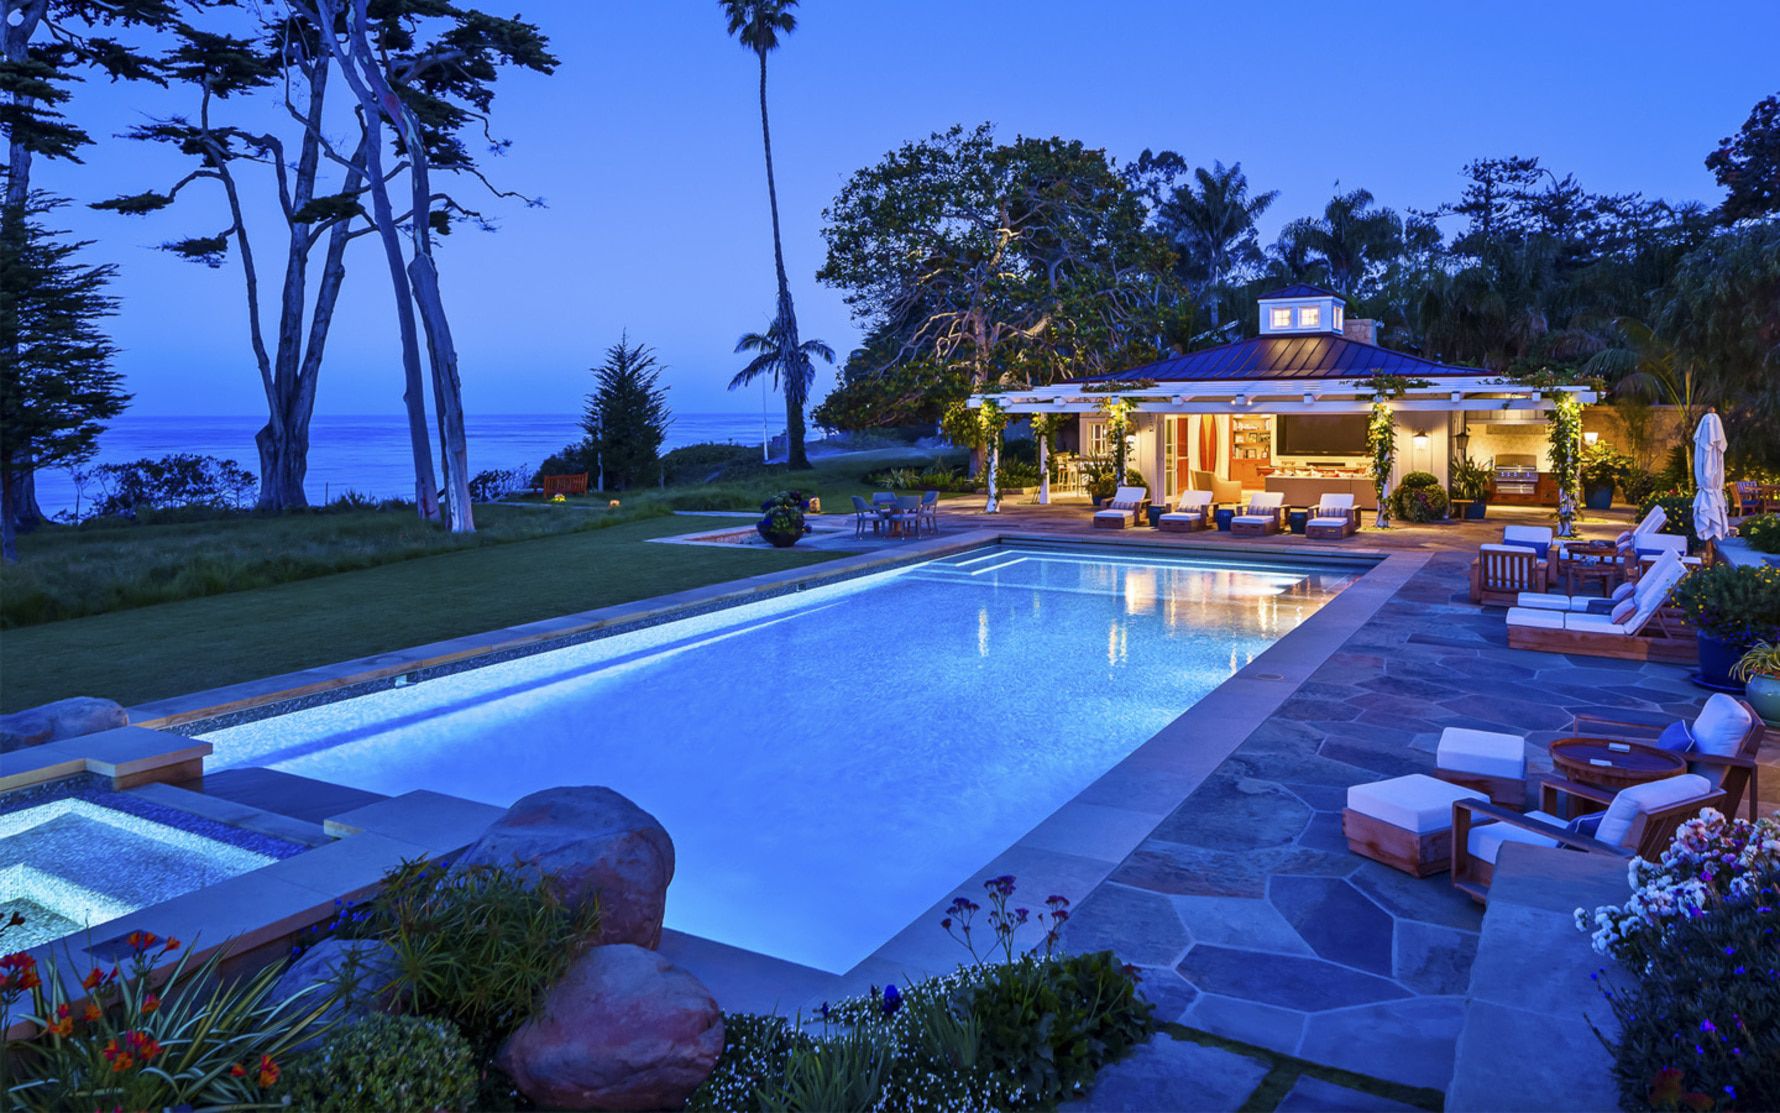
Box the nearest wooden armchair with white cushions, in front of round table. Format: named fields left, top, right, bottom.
left=1452, top=773, right=1725, bottom=903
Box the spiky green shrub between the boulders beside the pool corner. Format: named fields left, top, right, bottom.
left=335, top=860, right=600, bottom=1054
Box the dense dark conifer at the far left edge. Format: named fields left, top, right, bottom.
left=0, top=192, right=130, bottom=561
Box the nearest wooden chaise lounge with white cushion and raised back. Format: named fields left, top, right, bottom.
left=1508, top=552, right=1700, bottom=664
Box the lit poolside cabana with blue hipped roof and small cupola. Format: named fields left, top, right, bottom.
left=970, top=285, right=1595, bottom=509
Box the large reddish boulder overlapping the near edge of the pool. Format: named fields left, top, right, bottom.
left=454, top=785, right=673, bottom=947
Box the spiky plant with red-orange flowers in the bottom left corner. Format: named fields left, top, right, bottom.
left=0, top=931, right=329, bottom=1111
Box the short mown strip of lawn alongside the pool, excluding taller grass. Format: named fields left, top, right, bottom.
left=0, top=509, right=837, bottom=711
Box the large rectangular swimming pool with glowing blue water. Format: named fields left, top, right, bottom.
left=201, top=545, right=1358, bottom=972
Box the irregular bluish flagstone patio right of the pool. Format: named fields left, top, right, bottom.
left=1066, top=552, right=1737, bottom=1108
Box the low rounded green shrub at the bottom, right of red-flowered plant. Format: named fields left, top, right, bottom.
left=290, top=1015, right=477, bottom=1113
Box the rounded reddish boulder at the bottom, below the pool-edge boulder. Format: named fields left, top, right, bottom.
left=497, top=944, right=723, bottom=1109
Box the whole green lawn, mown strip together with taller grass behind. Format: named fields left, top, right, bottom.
left=0, top=451, right=961, bottom=711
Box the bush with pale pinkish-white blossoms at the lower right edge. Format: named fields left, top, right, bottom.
left=1577, top=808, right=1780, bottom=1109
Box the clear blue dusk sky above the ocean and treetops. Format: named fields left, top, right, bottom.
left=37, top=0, right=1780, bottom=415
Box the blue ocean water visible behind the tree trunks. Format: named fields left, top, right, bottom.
left=37, top=413, right=785, bottom=515
